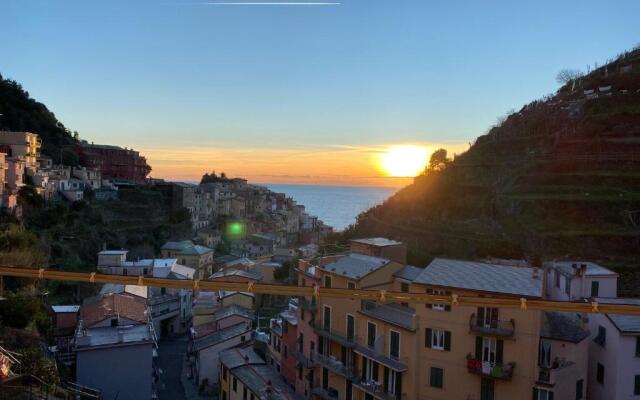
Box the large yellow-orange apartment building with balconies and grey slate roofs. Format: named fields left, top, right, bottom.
left=302, top=254, right=587, bottom=400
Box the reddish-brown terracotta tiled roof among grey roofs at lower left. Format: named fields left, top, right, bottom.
left=80, top=293, right=148, bottom=328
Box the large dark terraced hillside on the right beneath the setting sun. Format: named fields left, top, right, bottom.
left=345, top=49, right=640, bottom=296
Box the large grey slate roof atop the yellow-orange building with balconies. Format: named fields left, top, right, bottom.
left=414, top=258, right=542, bottom=297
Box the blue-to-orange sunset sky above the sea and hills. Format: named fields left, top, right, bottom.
left=5, top=0, right=640, bottom=186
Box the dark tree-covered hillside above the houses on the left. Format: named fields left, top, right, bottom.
left=0, top=75, right=78, bottom=165
